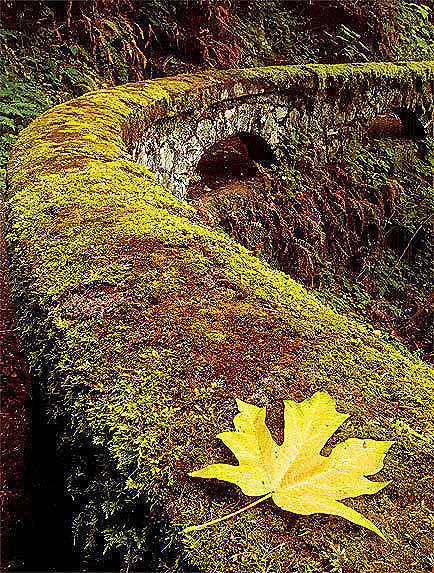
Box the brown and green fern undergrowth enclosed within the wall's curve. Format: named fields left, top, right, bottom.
left=193, top=134, right=433, bottom=360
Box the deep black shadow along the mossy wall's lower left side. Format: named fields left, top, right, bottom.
left=8, top=366, right=199, bottom=573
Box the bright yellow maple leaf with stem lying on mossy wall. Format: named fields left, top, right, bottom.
left=184, top=392, right=394, bottom=539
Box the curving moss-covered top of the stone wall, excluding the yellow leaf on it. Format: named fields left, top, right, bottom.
left=7, top=62, right=434, bottom=573
